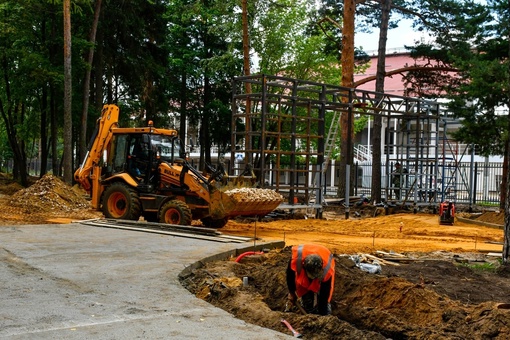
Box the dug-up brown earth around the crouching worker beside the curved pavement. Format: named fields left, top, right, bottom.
left=182, top=247, right=510, bottom=339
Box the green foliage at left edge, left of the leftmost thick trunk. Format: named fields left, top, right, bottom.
left=0, top=0, right=63, bottom=182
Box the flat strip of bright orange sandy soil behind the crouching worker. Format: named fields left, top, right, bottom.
left=221, top=212, right=503, bottom=254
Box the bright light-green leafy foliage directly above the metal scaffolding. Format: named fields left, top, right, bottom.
left=251, top=0, right=348, bottom=84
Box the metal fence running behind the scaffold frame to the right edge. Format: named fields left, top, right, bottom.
left=256, top=162, right=503, bottom=206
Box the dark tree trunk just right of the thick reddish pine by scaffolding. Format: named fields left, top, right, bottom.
left=371, top=0, right=391, bottom=202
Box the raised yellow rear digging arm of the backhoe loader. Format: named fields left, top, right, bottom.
left=74, top=105, right=119, bottom=193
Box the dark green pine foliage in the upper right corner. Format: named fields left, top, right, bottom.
left=407, top=0, right=510, bottom=156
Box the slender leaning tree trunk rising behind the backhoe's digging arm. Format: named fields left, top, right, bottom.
left=78, top=0, right=102, bottom=161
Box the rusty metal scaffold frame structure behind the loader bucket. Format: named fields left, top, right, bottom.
left=229, top=75, right=446, bottom=209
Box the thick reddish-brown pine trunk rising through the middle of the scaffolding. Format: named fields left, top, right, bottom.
left=338, top=0, right=356, bottom=202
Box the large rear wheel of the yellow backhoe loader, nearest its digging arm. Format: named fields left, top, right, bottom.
left=103, top=183, right=141, bottom=221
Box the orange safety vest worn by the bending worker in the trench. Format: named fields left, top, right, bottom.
left=290, top=244, right=335, bottom=302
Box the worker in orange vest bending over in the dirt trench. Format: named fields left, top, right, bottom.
left=287, top=244, right=335, bottom=315
